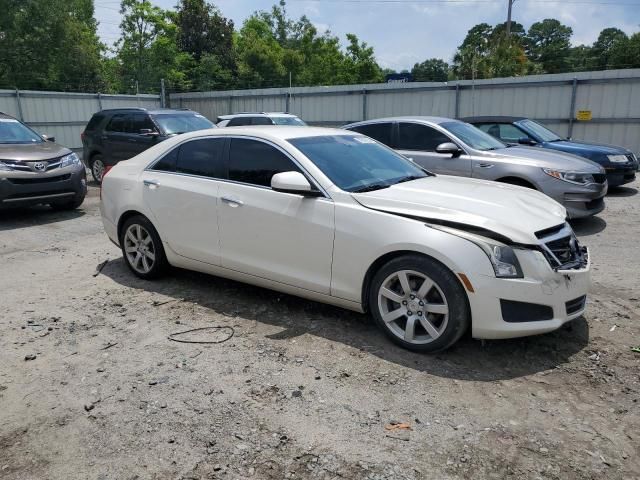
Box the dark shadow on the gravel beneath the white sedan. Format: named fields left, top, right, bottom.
left=102, top=258, right=589, bottom=382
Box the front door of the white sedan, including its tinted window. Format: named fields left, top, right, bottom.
left=218, top=138, right=334, bottom=294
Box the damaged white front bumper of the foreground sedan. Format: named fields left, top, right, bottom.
left=469, top=251, right=591, bottom=339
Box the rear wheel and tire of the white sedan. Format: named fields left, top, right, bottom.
left=120, top=215, right=168, bottom=280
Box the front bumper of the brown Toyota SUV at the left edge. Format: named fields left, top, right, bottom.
left=0, top=166, right=87, bottom=209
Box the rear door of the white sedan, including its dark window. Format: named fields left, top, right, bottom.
left=142, top=137, right=226, bottom=265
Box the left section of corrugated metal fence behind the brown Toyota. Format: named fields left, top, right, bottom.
left=0, top=90, right=160, bottom=150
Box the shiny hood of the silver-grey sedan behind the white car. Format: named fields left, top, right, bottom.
left=483, top=146, right=604, bottom=173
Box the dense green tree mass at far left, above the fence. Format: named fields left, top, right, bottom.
left=0, top=0, right=104, bottom=91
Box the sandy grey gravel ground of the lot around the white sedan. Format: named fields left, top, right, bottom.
left=0, top=182, right=640, bottom=480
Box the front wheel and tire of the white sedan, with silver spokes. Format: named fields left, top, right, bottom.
left=369, top=255, right=471, bottom=353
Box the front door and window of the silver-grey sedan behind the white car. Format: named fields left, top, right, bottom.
left=396, top=122, right=471, bottom=177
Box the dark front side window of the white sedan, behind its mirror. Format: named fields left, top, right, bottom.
left=229, top=138, right=300, bottom=187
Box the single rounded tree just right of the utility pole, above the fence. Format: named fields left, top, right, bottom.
left=526, top=18, right=573, bottom=73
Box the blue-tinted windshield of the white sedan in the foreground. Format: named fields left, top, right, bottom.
left=288, top=135, right=430, bottom=192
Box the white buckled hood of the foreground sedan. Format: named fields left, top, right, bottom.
left=352, top=175, right=567, bottom=244
